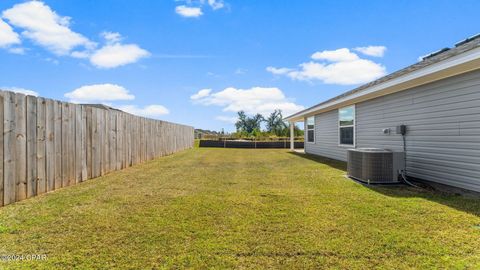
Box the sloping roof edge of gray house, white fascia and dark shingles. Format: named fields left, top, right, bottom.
left=285, top=34, right=480, bottom=122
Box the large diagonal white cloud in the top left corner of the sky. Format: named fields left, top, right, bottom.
left=2, top=1, right=95, bottom=55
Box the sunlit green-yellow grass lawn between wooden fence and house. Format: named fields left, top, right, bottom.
left=0, top=148, right=480, bottom=269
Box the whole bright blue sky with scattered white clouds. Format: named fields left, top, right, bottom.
left=0, top=0, right=480, bottom=131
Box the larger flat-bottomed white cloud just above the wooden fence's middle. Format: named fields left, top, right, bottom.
left=65, top=83, right=135, bottom=103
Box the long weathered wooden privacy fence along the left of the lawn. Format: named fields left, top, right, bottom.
left=0, top=91, right=194, bottom=206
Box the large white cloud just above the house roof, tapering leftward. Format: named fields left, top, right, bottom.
left=267, top=48, right=386, bottom=85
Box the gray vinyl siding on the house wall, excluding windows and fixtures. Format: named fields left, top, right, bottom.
left=305, top=71, right=480, bottom=191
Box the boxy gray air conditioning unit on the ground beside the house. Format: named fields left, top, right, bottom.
left=347, top=148, right=405, bottom=184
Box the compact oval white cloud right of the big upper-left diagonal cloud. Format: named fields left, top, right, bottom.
left=90, top=43, right=150, bottom=68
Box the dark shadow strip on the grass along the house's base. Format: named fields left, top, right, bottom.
left=290, top=152, right=480, bottom=217
